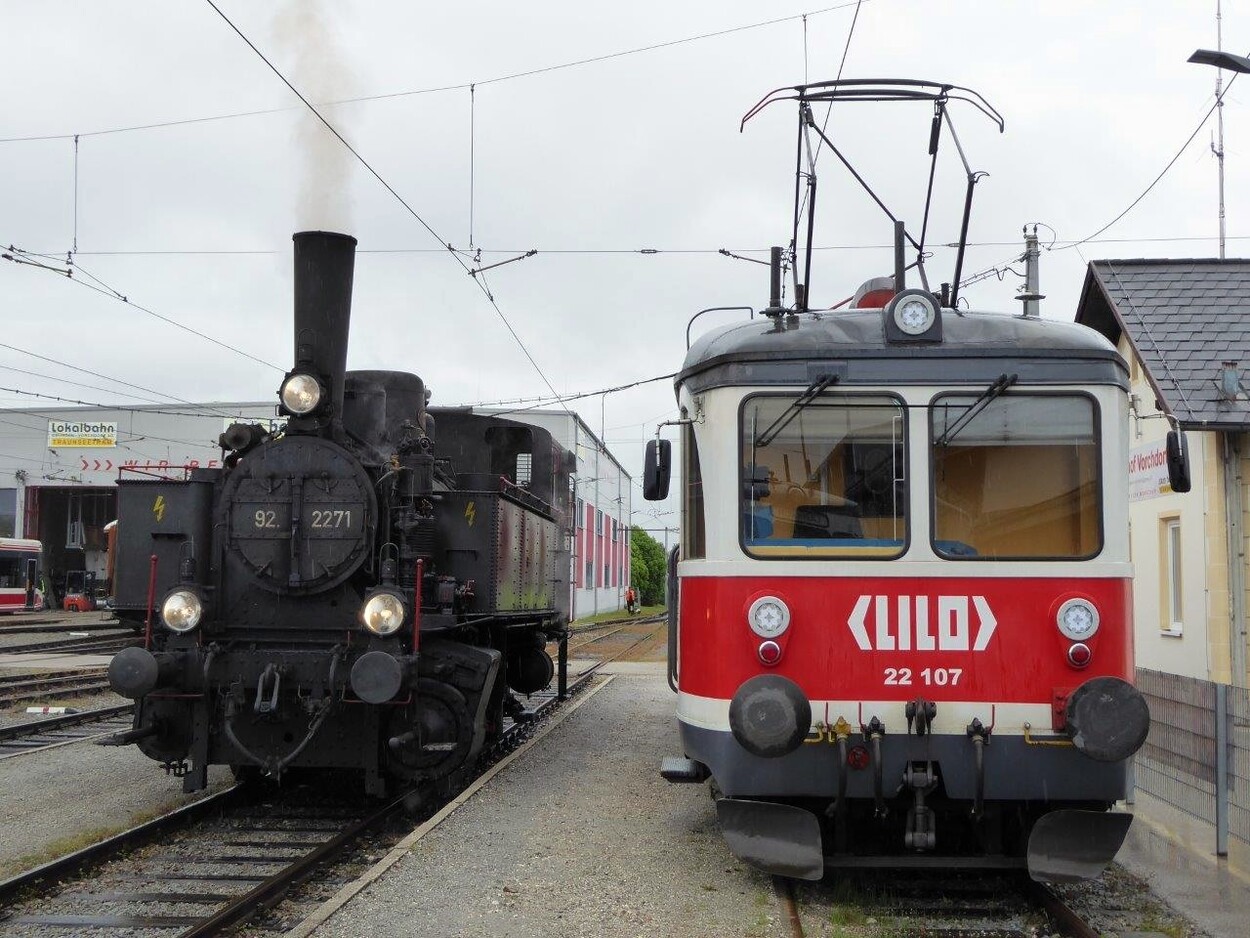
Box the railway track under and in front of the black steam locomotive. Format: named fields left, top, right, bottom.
left=0, top=655, right=630, bottom=938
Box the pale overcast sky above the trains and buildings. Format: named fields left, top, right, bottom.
left=0, top=0, right=1250, bottom=535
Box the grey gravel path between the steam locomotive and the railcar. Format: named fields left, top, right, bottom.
left=314, top=664, right=789, bottom=938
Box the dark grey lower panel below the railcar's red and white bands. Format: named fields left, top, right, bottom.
left=680, top=723, right=1126, bottom=802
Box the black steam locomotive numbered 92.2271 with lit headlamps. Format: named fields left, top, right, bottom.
left=109, top=231, right=575, bottom=794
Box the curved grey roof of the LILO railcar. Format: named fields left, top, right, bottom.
left=675, top=309, right=1128, bottom=391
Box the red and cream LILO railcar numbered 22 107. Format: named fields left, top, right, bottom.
left=666, top=297, right=1149, bottom=879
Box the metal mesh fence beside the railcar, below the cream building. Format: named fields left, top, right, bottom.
left=1134, top=668, right=1250, bottom=857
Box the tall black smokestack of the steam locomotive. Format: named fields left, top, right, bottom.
left=291, top=231, right=356, bottom=421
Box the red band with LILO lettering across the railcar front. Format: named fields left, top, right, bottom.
left=680, top=577, right=1133, bottom=703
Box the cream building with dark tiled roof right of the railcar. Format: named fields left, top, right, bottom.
left=1076, top=258, right=1250, bottom=687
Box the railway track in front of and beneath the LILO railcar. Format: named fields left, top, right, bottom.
left=774, top=870, right=1099, bottom=938
